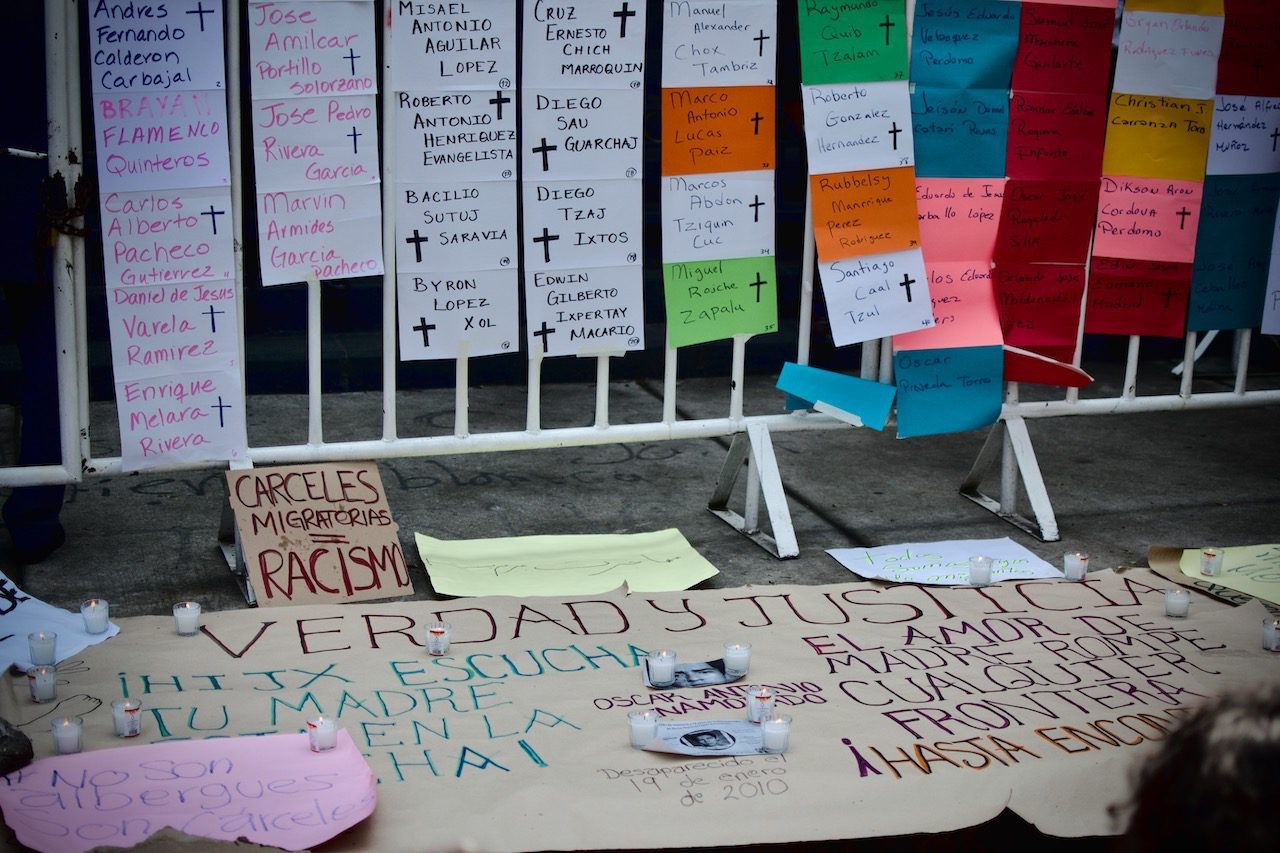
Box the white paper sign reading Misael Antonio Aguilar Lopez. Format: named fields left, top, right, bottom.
left=392, top=0, right=514, bottom=92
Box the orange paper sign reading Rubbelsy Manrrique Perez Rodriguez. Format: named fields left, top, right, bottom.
left=809, top=167, right=920, bottom=261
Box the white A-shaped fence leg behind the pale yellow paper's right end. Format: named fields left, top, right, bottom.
left=707, top=424, right=800, bottom=560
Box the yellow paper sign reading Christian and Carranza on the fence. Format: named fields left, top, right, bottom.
left=1102, top=92, right=1213, bottom=181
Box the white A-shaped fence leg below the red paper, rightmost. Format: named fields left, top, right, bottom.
left=960, top=418, right=1062, bottom=542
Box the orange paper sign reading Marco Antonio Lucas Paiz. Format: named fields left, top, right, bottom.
left=662, top=86, right=776, bottom=175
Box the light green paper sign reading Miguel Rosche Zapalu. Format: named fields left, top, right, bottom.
left=662, top=256, right=778, bottom=347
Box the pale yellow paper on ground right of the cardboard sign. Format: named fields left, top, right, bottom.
left=413, top=528, right=719, bottom=596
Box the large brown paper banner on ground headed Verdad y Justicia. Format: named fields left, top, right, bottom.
left=0, top=569, right=1280, bottom=852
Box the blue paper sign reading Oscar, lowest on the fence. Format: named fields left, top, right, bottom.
left=893, top=347, right=1005, bottom=438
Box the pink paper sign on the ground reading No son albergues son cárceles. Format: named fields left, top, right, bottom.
left=0, top=730, right=378, bottom=853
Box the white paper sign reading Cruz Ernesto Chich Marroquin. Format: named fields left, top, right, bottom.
left=524, top=0, right=645, bottom=90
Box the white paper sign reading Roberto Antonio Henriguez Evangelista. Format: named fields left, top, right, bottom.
left=396, top=90, right=516, bottom=182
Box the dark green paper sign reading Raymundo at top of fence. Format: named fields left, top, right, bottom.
left=799, top=0, right=908, bottom=86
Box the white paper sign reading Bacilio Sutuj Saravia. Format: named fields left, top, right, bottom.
left=396, top=181, right=517, bottom=273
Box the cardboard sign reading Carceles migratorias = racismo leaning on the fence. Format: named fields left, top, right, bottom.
left=227, top=462, right=413, bottom=607
